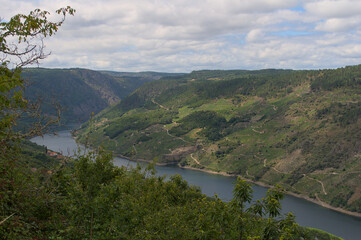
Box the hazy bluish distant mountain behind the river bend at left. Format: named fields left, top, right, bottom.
left=23, top=68, right=181, bottom=124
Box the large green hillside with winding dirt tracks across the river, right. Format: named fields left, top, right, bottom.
left=78, top=65, right=361, bottom=212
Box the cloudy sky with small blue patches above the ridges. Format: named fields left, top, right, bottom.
left=0, top=0, right=361, bottom=72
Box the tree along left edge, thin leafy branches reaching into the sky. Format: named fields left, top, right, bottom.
left=0, top=7, right=75, bottom=239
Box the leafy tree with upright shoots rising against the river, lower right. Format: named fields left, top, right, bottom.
left=232, top=178, right=299, bottom=240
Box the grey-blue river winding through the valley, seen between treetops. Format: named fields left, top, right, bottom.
left=31, top=131, right=361, bottom=240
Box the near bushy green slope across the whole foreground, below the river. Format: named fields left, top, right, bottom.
left=0, top=66, right=340, bottom=240
